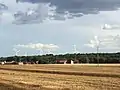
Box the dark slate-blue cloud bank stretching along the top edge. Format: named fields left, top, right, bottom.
left=16, top=0, right=120, bottom=14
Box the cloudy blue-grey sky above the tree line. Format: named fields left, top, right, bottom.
left=0, top=0, right=120, bottom=56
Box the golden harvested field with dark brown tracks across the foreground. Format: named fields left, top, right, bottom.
left=0, top=64, right=120, bottom=90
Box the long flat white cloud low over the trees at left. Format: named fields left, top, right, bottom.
left=15, top=43, right=59, bottom=51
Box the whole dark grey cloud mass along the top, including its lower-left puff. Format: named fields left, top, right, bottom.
left=13, top=0, right=120, bottom=24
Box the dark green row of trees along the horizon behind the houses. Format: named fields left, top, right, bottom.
left=0, top=53, right=120, bottom=64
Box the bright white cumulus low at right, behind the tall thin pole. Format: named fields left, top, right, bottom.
left=85, top=35, right=120, bottom=49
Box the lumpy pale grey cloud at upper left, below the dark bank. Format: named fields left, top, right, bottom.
left=13, top=3, right=75, bottom=24
